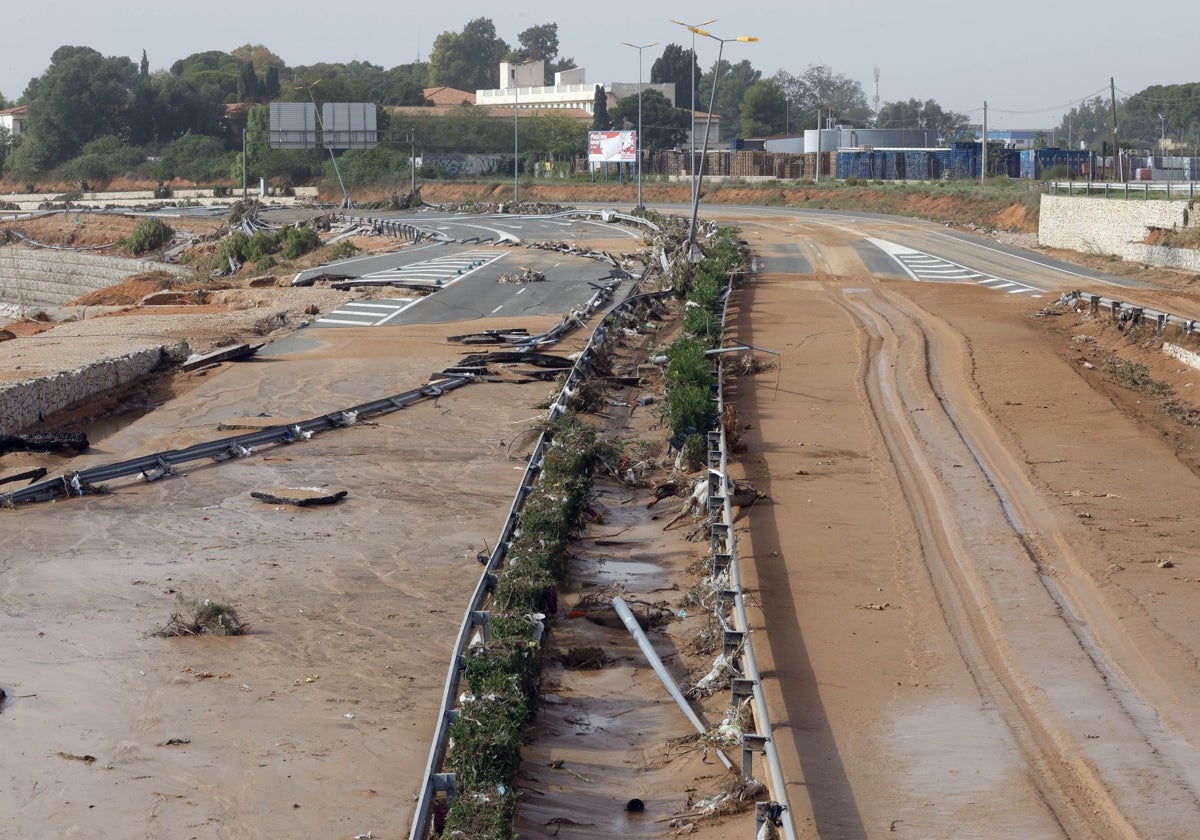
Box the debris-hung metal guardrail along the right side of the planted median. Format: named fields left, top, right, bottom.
left=708, top=283, right=797, bottom=840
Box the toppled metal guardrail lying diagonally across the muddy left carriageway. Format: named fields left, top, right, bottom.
left=0, top=376, right=474, bottom=505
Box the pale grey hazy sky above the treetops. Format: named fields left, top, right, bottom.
left=0, top=0, right=1200, bottom=128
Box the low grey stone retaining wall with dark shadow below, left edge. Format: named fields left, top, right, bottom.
left=0, top=346, right=164, bottom=436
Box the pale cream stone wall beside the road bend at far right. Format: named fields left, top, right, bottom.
left=1038, top=196, right=1192, bottom=259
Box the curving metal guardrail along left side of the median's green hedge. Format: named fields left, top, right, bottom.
left=408, top=281, right=672, bottom=840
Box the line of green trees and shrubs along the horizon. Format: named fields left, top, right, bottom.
left=0, top=18, right=1200, bottom=190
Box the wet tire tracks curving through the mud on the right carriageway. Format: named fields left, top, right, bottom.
left=840, top=287, right=1200, bottom=838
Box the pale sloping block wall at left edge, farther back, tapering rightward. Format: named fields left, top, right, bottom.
left=0, top=245, right=184, bottom=308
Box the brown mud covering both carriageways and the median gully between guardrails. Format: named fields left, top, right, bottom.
left=0, top=198, right=1200, bottom=838
